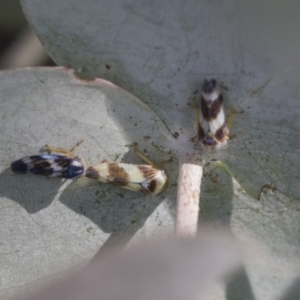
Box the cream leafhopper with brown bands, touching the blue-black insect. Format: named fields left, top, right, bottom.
left=85, top=145, right=168, bottom=195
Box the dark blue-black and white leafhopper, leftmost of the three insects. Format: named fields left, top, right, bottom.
left=10, top=141, right=86, bottom=179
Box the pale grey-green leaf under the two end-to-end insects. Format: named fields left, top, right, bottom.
left=0, top=68, right=177, bottom=299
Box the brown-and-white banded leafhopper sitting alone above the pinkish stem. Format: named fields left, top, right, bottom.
left=196, top=79, right=229, bottom=152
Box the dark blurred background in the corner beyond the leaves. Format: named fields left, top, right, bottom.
left=0, top=0, right=55, bottom=70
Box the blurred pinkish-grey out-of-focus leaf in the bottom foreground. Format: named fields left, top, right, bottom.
left=22, top=231, right=242, bottom=300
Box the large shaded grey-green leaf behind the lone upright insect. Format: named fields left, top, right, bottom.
left=22, top=0, right=300, bottom=200
